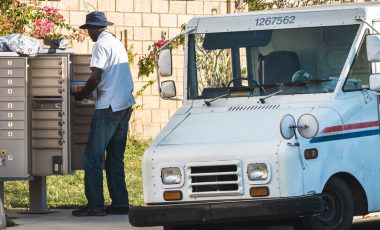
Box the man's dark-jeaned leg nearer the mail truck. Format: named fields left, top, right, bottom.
left=106, top=108, right=132, bottom=208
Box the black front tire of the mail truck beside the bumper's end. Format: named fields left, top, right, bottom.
left=295, top=177, right=354, bottom=230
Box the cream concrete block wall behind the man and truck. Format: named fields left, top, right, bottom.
left=42, top=0, right=230, bottom=138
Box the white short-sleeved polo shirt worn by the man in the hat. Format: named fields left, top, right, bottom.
left=90, top=31, right=135, bottom=112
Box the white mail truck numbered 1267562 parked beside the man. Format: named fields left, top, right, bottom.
left=129, top=3, right=380, bottom=230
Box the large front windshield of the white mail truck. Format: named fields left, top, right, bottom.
left=188, top=24, right=359, bottom=99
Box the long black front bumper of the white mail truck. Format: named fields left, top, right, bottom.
left=129, top=195, right=323, bottom=227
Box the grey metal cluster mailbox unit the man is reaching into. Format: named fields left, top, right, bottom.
left=0, top=52, right=94, bottom=203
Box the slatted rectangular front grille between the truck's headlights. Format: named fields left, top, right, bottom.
left=189, top=162, right=242, bottom=197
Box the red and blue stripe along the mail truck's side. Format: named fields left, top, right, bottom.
left=310, top=121, right=380, bottom=143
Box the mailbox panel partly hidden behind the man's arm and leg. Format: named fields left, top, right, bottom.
left=71, top=55, right=95, bottom=170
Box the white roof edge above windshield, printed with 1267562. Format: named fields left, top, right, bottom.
left=187, top=2, right=380, bottom=33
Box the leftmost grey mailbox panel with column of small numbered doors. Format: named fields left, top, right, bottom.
left=0, top=57, right=30, bottom=179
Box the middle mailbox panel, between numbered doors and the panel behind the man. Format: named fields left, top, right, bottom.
left=30, top=55, right=71, bottom=176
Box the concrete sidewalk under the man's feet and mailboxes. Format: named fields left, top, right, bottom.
left=5, top=209, right=162, bottom=230
